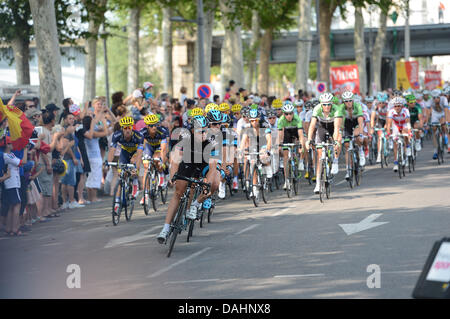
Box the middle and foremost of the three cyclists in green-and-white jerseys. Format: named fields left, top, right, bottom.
left=306, top=93, right=343, bottom=194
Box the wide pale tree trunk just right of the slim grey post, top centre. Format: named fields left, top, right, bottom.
left=220, top=0, right=244, bottom=96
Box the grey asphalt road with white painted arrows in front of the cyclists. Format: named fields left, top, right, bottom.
left=0, top=142, right=450, bottom=299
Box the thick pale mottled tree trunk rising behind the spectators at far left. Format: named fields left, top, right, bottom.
left=30, top=0, right=64, bottom=107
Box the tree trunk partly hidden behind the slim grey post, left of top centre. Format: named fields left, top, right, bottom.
left=194, top=2, right=217, bottom=82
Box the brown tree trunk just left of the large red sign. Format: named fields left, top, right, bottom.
left=317, top=0, right=337, bottom=84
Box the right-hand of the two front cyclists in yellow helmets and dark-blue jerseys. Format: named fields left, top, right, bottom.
left=139, top=114, right=170, bottom=205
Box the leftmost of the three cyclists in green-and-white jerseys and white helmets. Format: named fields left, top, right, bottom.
left=278, top=103, right=305, bottom=189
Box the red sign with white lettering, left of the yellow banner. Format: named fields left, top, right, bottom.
left=330, top=64, right=359, bottom=94
